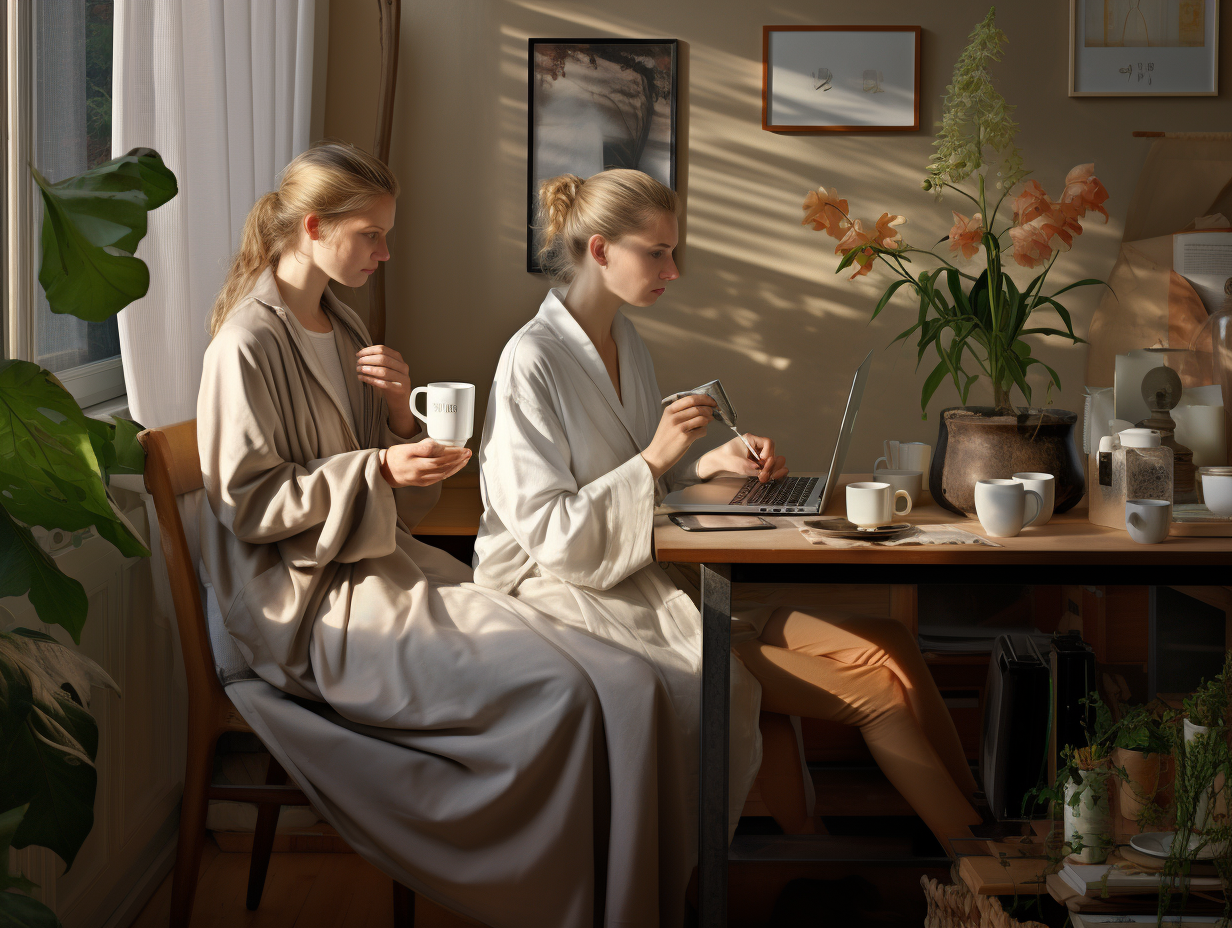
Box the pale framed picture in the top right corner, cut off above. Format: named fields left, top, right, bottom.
left=1069, top=0, right=1220, bottom=96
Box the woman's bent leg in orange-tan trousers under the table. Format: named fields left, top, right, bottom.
left=737, top=616, right=981, bottom=850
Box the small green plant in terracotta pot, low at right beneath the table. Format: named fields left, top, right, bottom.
left=1111, top=702, right=1172, bottom=831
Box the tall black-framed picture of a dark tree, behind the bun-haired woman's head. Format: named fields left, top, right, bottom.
left=526, top=38, right=676, bottom=272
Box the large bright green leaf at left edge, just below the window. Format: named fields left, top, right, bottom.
left=0, top=361, right=149, bottom=557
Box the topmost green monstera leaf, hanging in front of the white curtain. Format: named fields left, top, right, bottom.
left=31, top=148, right=177, bottom=322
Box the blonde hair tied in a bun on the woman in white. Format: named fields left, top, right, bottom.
left=535, top=168, right=679, bottom=283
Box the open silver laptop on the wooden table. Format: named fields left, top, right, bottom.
left=663, top=351, right=872, bottom=515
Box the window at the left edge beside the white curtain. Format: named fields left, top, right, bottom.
left=6, top=0, right=124, bottom=405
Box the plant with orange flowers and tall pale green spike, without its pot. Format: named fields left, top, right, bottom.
left=803, top=7, right=1108, bottom=418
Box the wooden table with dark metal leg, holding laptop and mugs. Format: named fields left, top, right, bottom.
left=654, top=474, right=1232, bottom=928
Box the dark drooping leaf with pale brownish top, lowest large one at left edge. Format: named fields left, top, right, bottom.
left=0, top=629, right=118, bottom=866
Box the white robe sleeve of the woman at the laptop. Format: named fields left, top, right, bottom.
left=483, top=357, right=654, bottom=590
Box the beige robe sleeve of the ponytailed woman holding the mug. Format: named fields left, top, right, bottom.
left=197, top=327, right=397, bottom=567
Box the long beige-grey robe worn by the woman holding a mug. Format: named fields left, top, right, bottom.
left=197, top=270, right=691, bottom=928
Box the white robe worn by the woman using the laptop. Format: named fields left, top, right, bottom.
left=474, top=290, right=761, bottom=828
